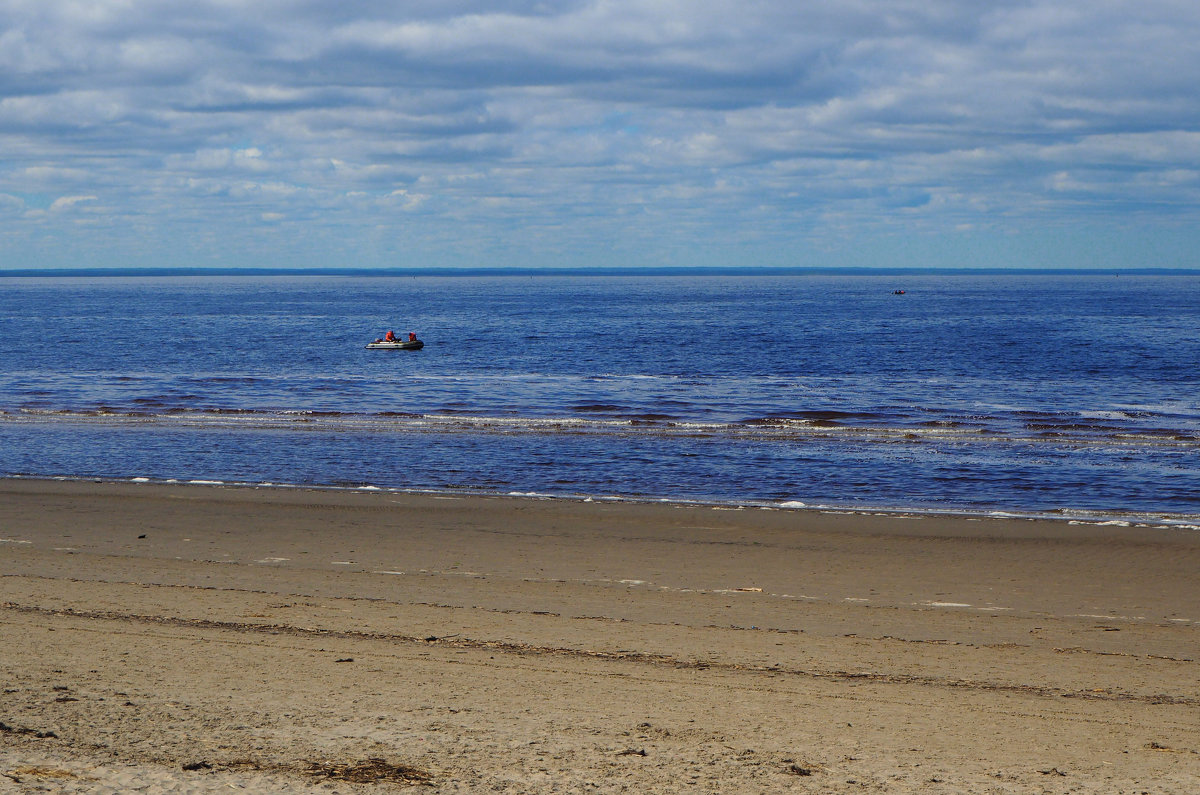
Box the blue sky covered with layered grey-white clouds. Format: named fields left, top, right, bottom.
left=0, top=0, right=1200, bottom=269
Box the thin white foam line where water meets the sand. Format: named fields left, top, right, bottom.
left=9, top=474, right=1200, bottom=531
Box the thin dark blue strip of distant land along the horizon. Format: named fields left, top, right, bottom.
left=0, top=265, right=1200, bottom=279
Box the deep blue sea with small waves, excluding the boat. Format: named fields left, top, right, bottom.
left=0, top=273, right=1200, bottom=525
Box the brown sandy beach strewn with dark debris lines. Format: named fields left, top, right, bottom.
left=0, top=479, right=1200, bottom=793
